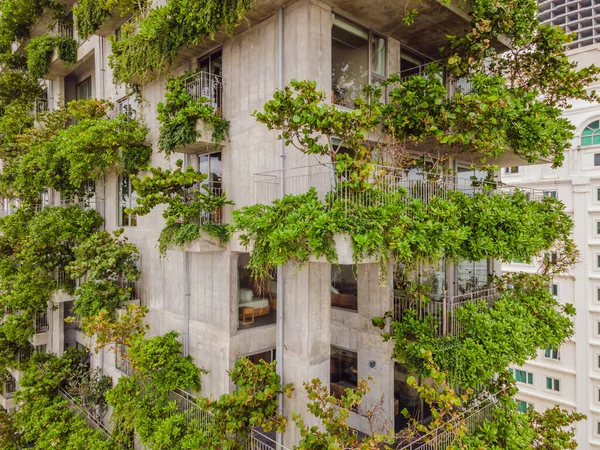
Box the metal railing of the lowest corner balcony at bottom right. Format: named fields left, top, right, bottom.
left=397, top=392, right=504, bottom=450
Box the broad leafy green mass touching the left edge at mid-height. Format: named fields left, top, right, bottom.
left=0, top=206, right=102, bottom=346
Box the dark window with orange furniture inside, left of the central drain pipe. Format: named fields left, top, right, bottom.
left=237, top=253, right=277, bottom=329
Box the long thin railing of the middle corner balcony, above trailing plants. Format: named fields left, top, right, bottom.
left=254, top=163, right=544, bottom=206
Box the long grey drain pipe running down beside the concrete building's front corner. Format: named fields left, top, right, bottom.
left=277, top=8, right=285, bottom=450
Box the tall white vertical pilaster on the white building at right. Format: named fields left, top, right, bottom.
left=572, top=177, right=595, bottom=443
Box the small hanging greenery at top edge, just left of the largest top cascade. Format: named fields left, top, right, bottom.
left=73, top=0, right=146, bottom=39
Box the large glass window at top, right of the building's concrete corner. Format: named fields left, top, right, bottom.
left=331, top=14, right=387, bottom=108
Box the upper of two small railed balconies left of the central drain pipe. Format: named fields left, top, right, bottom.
left=178, top=72, right=223, bottom=153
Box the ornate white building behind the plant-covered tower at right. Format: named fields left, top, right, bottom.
left=502, top=0, right=600, bottom=450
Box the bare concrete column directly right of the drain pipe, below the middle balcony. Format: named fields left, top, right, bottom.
left=277, top=263, right=331, bottom=448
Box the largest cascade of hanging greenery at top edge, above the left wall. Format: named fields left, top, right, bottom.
left=109, top=0, right=252, bottom=83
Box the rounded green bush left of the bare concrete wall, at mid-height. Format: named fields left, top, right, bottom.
left=67, top=228, right=140, bottom=318
